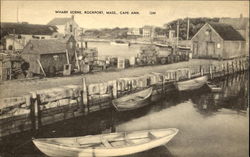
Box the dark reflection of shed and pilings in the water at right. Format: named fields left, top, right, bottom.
left=191, top=72, right=249, bottom=114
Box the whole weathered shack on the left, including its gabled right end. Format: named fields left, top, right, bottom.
left=21, top=37, right=76, bottom=76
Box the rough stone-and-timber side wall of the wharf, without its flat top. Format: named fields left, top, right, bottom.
left=0, top=58, right=249, bottom=140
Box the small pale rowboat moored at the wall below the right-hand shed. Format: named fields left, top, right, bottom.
left=175, top=76, right=208, bottom=91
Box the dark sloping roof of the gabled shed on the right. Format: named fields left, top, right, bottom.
left=208, top=22, right=245, bottom=41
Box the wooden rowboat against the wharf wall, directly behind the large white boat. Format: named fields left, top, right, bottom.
left=112, top=87, right=153, bottom=111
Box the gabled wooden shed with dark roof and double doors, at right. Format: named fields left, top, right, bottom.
left=191, top=23, right=246, bottom=59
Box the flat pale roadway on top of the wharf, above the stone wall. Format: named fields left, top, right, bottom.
left=0, top=59, right=226, bottom=99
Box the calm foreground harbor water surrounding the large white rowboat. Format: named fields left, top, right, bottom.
left=0, top=73, right=249, bottom=157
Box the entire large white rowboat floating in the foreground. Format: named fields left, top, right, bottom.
left=33, top=128, right=178, bottom=157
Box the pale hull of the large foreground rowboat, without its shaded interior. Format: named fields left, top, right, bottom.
left=33, top=128, right=178, bottom=157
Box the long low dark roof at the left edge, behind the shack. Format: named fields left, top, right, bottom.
left=1, top=22, right=57, bottom=38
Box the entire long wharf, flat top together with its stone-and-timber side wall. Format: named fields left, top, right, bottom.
left=0, top=58, right=249, bottom=140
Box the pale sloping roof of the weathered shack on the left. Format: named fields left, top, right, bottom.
left=22, top=39, right=66, bottom=54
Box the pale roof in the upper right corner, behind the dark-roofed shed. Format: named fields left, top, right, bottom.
left=219, top=17, right=249, bottom=30
